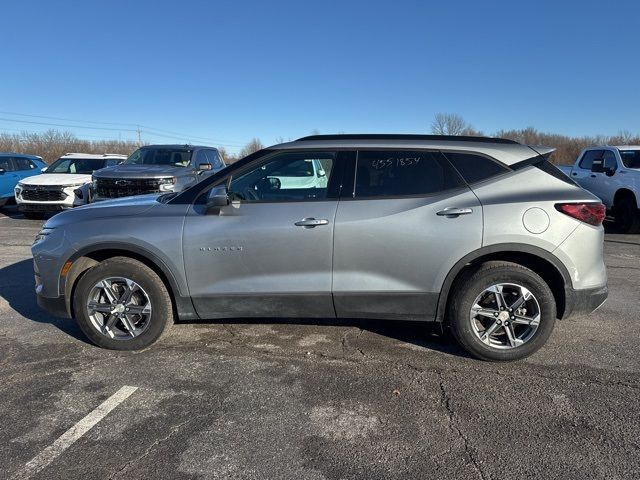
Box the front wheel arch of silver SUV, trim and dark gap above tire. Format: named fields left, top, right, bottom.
left=61, top=242, right=198, bottom=320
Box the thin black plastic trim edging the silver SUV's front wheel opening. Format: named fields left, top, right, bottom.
left=65, top=241, right=200, bottom=320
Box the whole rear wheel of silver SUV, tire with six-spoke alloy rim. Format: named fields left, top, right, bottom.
left=448, top=262, right=557, bottom=361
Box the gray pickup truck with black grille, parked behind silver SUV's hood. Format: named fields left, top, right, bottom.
left=92, top=145, right=225, bottom=201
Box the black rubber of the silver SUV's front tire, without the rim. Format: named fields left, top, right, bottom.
left=73, top=257, right=174, bottom=350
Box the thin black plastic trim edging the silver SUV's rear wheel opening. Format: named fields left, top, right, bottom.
left=435, top=243, right=573, bottom=322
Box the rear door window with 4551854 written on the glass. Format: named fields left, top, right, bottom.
left=354, top=150, right=462, bottom=198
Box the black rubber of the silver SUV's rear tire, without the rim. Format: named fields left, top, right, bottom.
left=448, top=262, right=557, bottom=361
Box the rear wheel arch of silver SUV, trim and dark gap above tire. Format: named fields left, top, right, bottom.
left=435, top=243, right=573, bottom=322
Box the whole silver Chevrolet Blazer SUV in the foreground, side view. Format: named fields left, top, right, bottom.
left=32, top=135, right=607, bottom=360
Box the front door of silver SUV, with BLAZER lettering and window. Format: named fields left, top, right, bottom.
left=183, top=151, right=341, bottom=318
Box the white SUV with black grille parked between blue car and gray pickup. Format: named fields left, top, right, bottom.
left=15, top=153, right=127, bottom=218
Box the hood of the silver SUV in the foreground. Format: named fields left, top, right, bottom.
left=44, top=194, right=163, bottom=228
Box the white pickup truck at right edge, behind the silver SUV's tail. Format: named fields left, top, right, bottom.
left=560, top=146, right=640, bottom=233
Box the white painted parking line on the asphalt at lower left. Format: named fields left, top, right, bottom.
left=13, top=386, right=138, bottom=480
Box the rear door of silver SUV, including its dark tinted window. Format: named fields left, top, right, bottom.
left=333, top=150, right=482, bottom=320
